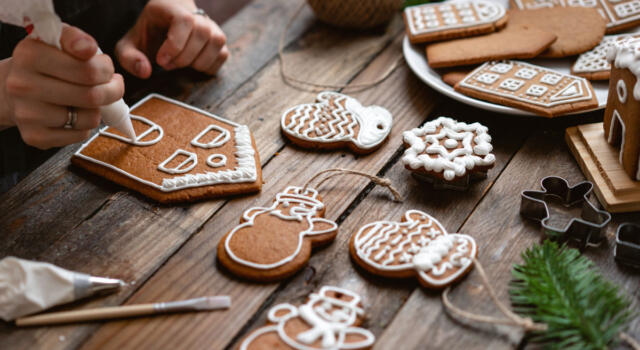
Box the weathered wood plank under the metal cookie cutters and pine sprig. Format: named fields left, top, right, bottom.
left=376, top=132, right=640, bottom=349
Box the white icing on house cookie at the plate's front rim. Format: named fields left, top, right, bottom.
left=459, top=61, right=593, bottom=107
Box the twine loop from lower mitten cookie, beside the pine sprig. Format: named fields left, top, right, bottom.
left=442, top=258, right=547, bottom=331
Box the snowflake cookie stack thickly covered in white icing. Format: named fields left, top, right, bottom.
left=402, top=117, right=496, bottom=187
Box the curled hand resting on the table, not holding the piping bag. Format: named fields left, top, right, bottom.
left=116, top=0, right=229, bottom=78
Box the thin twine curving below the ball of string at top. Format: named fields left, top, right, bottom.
left=278, top=1, right=403, bottom=92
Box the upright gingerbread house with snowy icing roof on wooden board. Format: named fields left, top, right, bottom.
left=604, top=39, right=640, bottom=181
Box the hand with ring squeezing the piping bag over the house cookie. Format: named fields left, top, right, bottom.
left=0, top=26, right=124, bottom=149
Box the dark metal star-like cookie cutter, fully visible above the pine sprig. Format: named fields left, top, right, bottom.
left=520, top=176, right=611, bottom=250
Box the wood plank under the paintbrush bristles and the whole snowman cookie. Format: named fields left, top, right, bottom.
left=76, top=40, right=440, bottom=349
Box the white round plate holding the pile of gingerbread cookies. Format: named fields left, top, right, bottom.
left=402, top=35, right=609, bottom=115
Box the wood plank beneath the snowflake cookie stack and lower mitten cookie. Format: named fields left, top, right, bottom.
left=222, top=98, right=527, bottom=349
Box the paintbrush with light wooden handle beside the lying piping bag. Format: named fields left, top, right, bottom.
left=16, top=296, right=231, bottom=326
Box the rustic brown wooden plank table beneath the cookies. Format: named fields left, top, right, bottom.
left=0, top=0, right=640, bottom=349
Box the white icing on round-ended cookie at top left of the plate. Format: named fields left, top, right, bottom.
left=404, top=0, right=507, bottom=35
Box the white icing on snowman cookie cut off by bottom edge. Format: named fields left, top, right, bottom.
left=240, top=286, right=375, bottom=350
